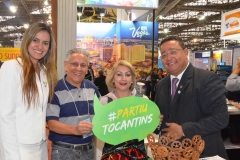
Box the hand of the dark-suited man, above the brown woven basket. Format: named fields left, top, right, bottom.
left=162, top=123, right=183, bottom=139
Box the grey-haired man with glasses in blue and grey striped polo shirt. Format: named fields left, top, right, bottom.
left=47, top=48, right=100, bottom=160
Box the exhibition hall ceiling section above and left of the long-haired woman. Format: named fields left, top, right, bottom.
left=0, top=0, right=51, bottom=47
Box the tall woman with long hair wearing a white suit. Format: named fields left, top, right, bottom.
left=0, top=23, right=57, bottom=160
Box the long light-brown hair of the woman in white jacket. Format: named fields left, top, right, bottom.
left=20, top=22, right=58, bottom=108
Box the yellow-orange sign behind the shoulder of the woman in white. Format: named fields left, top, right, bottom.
left=0, top=48, right=20, bottom=62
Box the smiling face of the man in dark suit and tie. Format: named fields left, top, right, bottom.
left=160, top=40, right=188, bottom=76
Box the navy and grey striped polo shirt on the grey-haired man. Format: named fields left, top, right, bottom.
left=46, top=75, right=100, bottom=144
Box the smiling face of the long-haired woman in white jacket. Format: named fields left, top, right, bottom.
left=28, top=31, right=50, bottom=65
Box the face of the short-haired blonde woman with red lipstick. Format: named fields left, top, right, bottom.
left=113, top=65, right=133, bottom=92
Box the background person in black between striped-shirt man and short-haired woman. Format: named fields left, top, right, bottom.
left=94, top=70, right=109, bottom=96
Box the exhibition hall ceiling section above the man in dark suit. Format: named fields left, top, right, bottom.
left=155, top=0, right=240, bottom=50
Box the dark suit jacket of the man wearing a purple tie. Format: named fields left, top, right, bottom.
left=155, top=64, right=228, bottom=158
